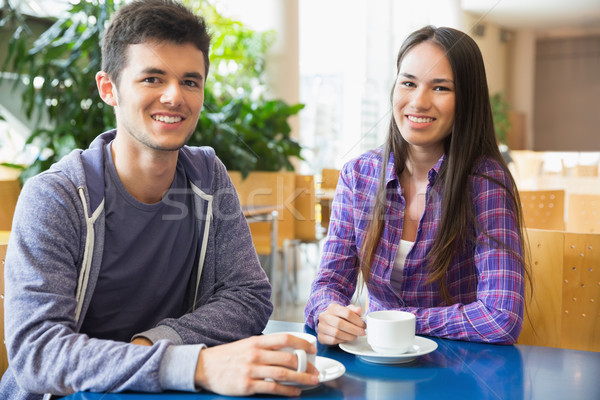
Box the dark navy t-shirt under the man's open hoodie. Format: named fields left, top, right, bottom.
left=81, top=144, right=198, bottom=342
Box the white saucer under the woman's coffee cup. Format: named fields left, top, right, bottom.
left=340, top=336, right=437, bottom=364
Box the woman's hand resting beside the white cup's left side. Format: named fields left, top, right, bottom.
left=317, top=303, right=367, bottom=345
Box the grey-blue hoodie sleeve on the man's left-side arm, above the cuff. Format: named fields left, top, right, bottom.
left=5, top=172, right=190, bottom=395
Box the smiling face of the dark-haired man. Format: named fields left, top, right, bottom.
left=105, top=42, right=206, bottom=151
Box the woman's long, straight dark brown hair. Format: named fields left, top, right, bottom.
left=360, top=26, right=527, bottom=305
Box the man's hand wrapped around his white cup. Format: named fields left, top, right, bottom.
left=195, top=333, right=319, bottom=396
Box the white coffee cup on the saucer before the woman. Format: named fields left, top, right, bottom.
left=367, top=310, right=416, bottom=355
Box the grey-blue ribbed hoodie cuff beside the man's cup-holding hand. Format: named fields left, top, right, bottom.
left=158, top=344, right=206, bottom=392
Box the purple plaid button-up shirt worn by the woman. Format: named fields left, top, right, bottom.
left=305, top=150, right=524, bottom=344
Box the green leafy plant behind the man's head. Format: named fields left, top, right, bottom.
left=0, top=0, right=303, bottom=179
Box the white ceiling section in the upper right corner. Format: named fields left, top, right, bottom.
left=461, top=0, right=600, bottom=30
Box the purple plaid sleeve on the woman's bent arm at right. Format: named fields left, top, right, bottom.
left=405, top=162, right=524, bottom=344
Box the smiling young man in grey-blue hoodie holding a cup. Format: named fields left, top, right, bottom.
left=0, top=0, right=318, bottom=399
